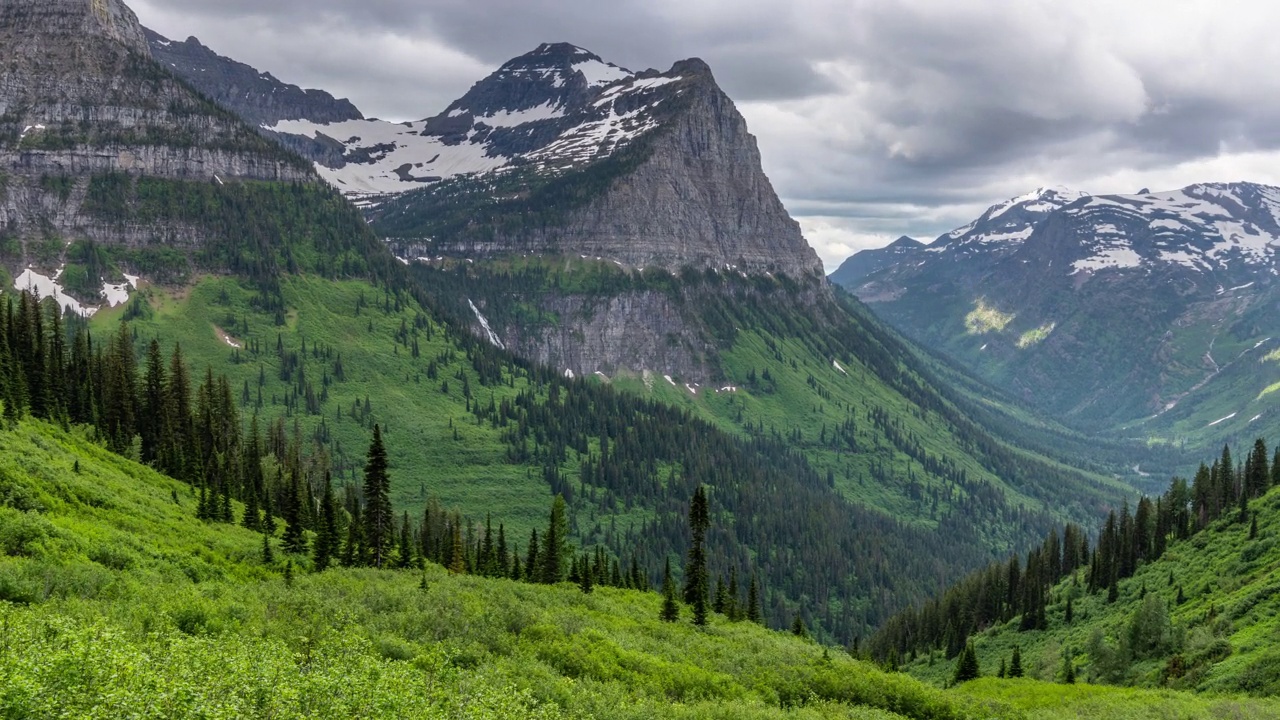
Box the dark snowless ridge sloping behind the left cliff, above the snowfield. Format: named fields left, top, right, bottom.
left=143, top=28, right=365, bottom=126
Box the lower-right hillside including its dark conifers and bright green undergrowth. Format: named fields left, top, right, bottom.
left=876, top=441, right=1280, bottom=697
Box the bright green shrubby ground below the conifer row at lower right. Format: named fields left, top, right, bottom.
left=890, top=474, right=1280, bottom=696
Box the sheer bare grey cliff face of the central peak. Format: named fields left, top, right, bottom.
left=406, top=60, right=822, bottom=278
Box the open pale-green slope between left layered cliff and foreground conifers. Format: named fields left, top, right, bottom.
left=95, top=275, right=558, bottom=541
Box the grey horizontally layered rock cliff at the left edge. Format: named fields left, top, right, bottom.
left=0, top=0, right=315, bottom=311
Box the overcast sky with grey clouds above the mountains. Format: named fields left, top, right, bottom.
left=129, top=0, right=1280, bottom=270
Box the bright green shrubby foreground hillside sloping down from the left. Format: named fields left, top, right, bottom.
left=0, top=412, right=1280, bottom=720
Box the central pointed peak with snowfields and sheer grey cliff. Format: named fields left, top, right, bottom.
left=256, top=44, right=820, bottom=278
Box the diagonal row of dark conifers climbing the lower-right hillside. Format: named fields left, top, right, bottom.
left=870, top=438, right=1280, bottom=660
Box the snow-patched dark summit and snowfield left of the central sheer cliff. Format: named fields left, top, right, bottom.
left=264, top=44, right=686, bottom=204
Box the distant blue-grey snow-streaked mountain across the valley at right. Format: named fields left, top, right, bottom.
left=846, top=183, right=1280, bottom=442
